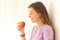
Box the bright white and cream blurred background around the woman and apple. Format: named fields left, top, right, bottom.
left=0, top=0, right=60, bottom=40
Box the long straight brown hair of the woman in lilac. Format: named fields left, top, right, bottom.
left=28, top=2, right=55, bottom=39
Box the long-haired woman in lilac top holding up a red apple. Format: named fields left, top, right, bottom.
left=18, top=2, right=54, bottom=40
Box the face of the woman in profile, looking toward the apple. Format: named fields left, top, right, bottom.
left=29, top=7, right=40, bottom=22
